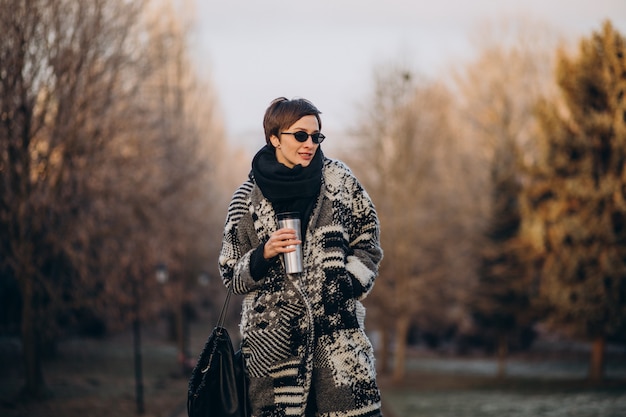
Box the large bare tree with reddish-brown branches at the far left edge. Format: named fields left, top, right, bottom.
left=0, top=0, right=154, bottom=395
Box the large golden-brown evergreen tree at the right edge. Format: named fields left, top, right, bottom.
left=522, top=22, right=626, bottom=381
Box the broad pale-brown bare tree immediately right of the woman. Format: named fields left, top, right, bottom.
left=353, top=66, right=474, bottom=380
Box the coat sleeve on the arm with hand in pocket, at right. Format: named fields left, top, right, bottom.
left=346, top=169, right=383, bottom=300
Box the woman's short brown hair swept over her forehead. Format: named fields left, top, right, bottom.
left=263, top=97, right=322, bottom=145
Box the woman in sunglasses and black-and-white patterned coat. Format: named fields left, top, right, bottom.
left=219, top=97, right=382, bottom=417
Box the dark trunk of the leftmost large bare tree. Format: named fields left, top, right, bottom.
left=21, top=277, right=46, bottom=399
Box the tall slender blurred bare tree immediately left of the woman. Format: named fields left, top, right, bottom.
left=134, top=3, right=234, bottom=359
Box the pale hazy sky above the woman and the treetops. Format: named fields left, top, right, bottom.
left=191, top=0, right=626, bottom=150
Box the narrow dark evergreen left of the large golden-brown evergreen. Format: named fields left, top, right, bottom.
left=471, top=142, right=535, bottom=378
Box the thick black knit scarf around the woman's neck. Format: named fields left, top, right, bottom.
left=250, top=145, right=324, bottom=226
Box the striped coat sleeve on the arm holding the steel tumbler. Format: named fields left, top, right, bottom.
left=218, top=182, right=261, bottom=294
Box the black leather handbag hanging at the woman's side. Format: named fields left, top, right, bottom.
left=187, top=290, right=249, bottom=417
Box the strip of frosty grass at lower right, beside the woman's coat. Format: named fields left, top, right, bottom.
left=381, top=360, right=626, bottom=417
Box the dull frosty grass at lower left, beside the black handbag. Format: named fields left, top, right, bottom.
left=0, top=329, right=187, bottom=417
